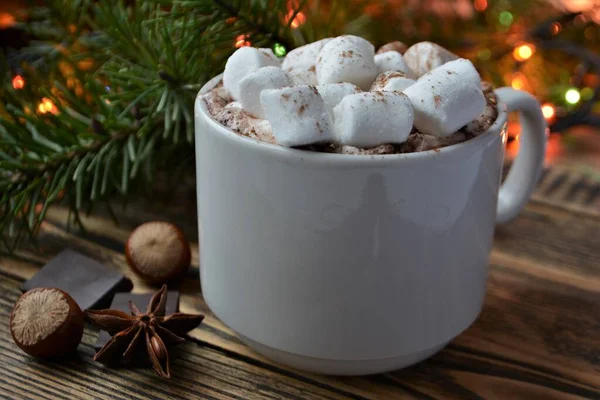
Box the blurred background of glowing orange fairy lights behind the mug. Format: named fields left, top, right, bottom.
left=0, top=0, right=600, bottom=164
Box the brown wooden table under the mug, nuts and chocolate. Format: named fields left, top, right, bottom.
left=0, top=158, right=600, bottom=399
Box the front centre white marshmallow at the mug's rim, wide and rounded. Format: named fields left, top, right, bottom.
left=333, top=92, right=413, bottom=148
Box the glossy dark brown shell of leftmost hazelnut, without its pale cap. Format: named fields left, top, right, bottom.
left=10, top=287, right=84, bottom=358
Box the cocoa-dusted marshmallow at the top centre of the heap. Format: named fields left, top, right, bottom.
left=317, top=35, right=377, bottom=90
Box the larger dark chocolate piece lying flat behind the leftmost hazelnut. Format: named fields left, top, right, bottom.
left=22, top=249, right=133, bottom=310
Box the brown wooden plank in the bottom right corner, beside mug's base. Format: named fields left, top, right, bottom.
left=388, top=265, right=600, bottom=398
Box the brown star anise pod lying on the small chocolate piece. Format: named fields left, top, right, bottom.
left=85, top=285, right=204, bottom=378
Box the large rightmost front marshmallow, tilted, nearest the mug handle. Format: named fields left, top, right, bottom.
left=404, top=59, right=486, bottom=137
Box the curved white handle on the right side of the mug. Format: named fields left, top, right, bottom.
left=496, top=87, right=548, bottom=223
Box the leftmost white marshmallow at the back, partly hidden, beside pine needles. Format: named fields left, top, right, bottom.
left=223, top=46, right=278, bottom=100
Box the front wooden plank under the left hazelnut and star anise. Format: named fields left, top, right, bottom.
left=0, top=275, right=366, bottom=399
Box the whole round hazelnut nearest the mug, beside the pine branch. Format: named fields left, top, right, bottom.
left=125, top=222, right=191, bottom=283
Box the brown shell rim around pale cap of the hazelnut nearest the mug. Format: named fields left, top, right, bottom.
left=125, top=221, right=192, bottom=284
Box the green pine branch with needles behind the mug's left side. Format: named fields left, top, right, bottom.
left=0, top=0, right=302, bottom=250
